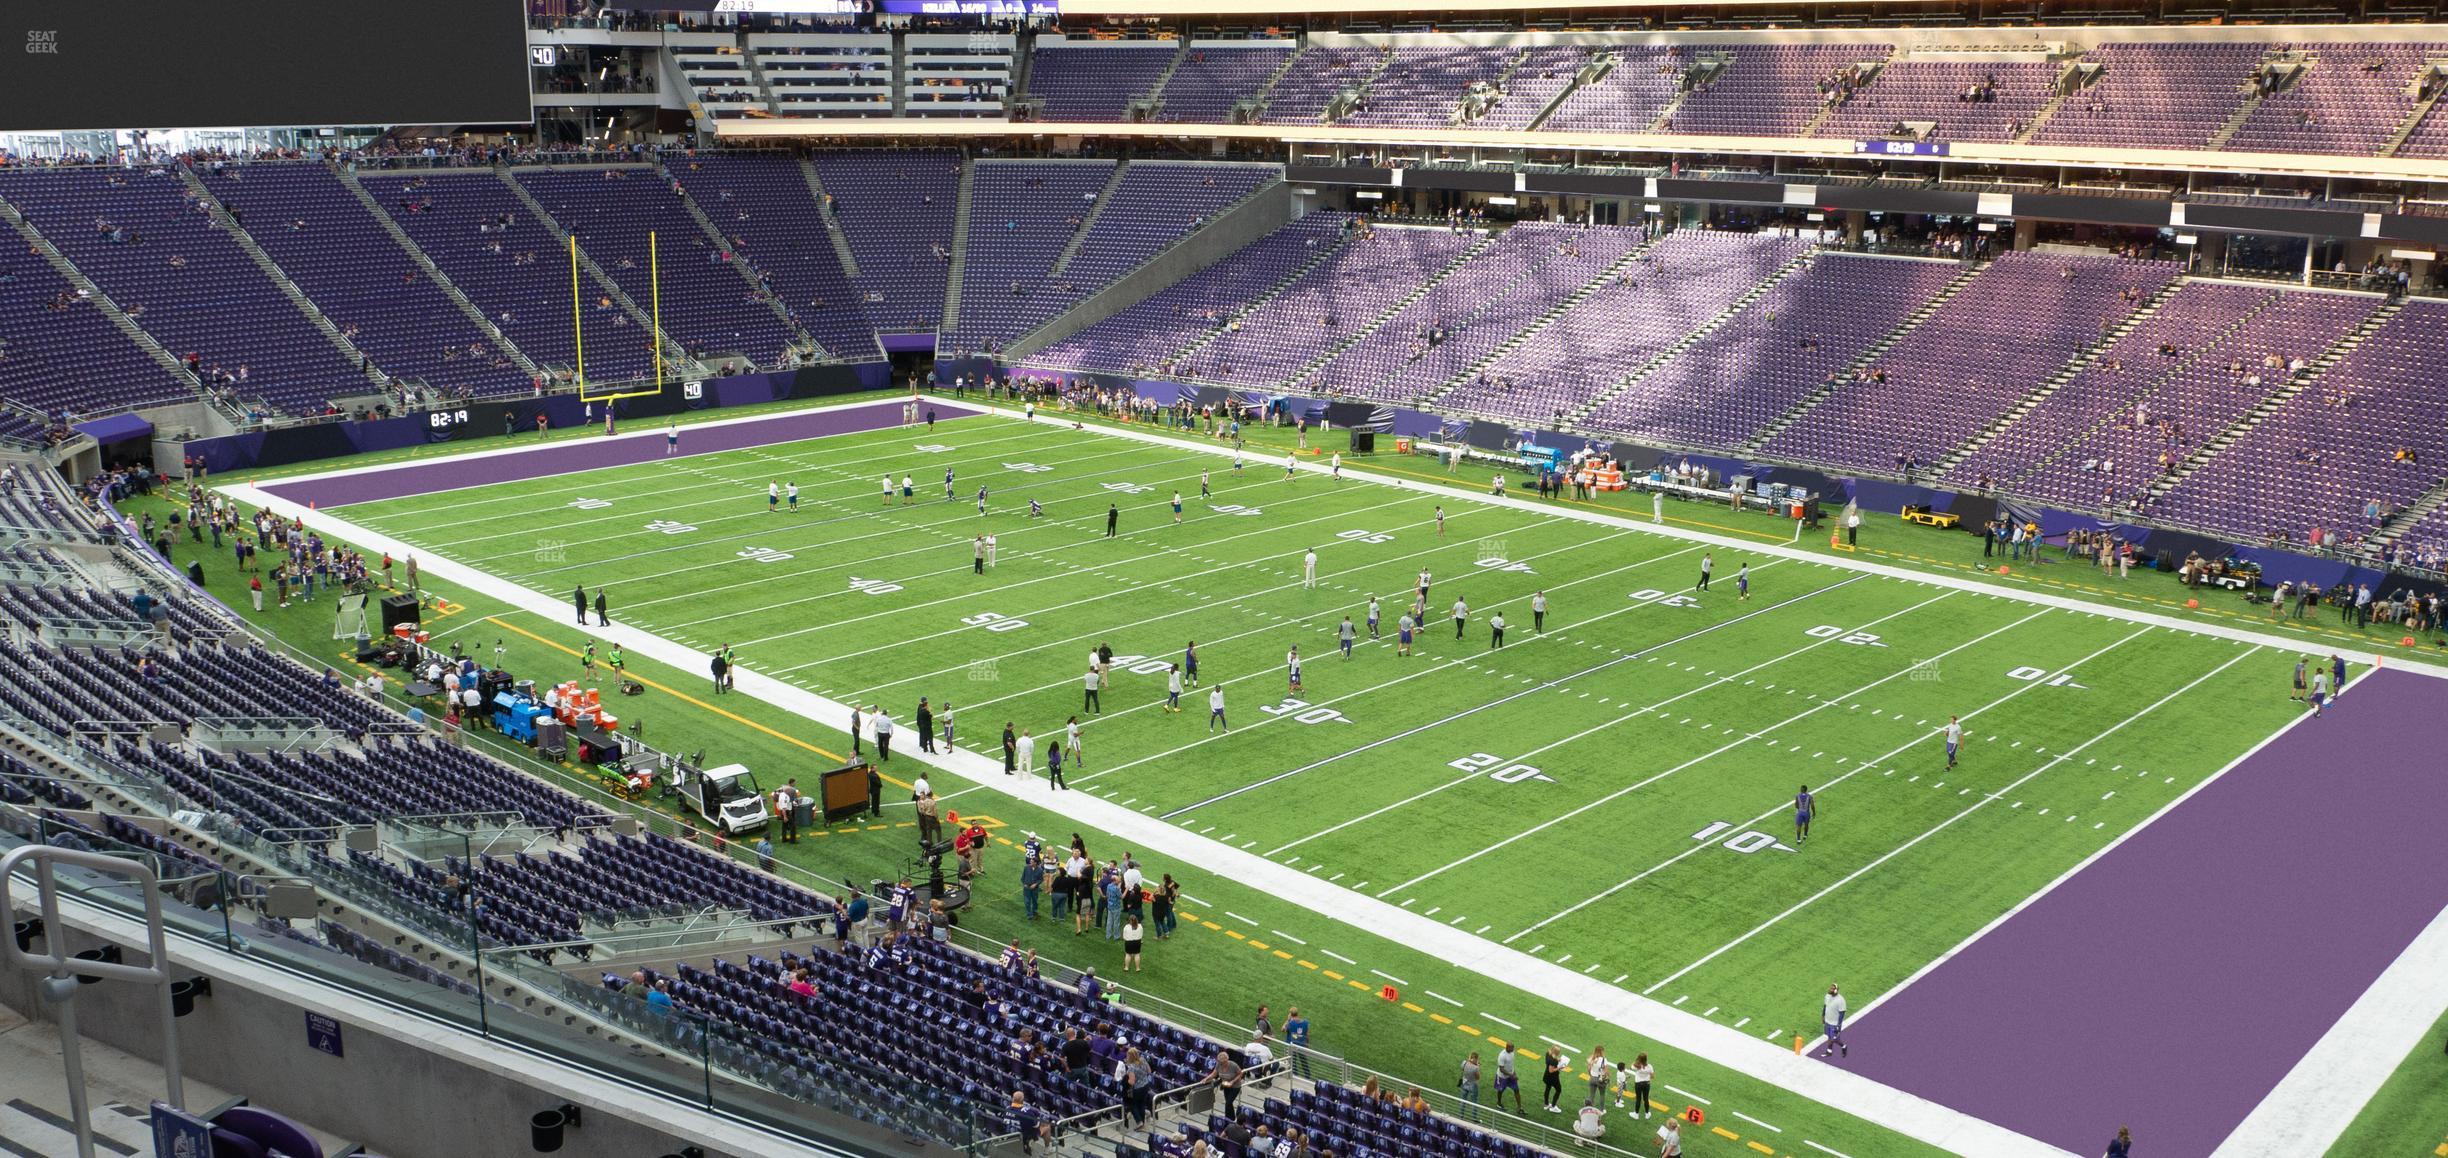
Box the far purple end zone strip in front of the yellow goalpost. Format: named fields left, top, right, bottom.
left=264, top=402, right=977, bottom=507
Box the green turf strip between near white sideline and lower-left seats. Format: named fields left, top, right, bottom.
left=140, top=504, right=1939, bottom=1156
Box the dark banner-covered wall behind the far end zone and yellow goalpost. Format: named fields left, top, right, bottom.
left=181, top=362, right=891, bottom=475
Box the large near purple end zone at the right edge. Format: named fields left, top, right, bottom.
left=1836, top=671, right=2448, bottom=1158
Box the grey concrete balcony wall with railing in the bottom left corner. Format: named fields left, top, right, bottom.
left=0, top=913, right=955, bottom=1158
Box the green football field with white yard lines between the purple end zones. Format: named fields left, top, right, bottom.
left=301, top=403, right=2299, bottom=1040
